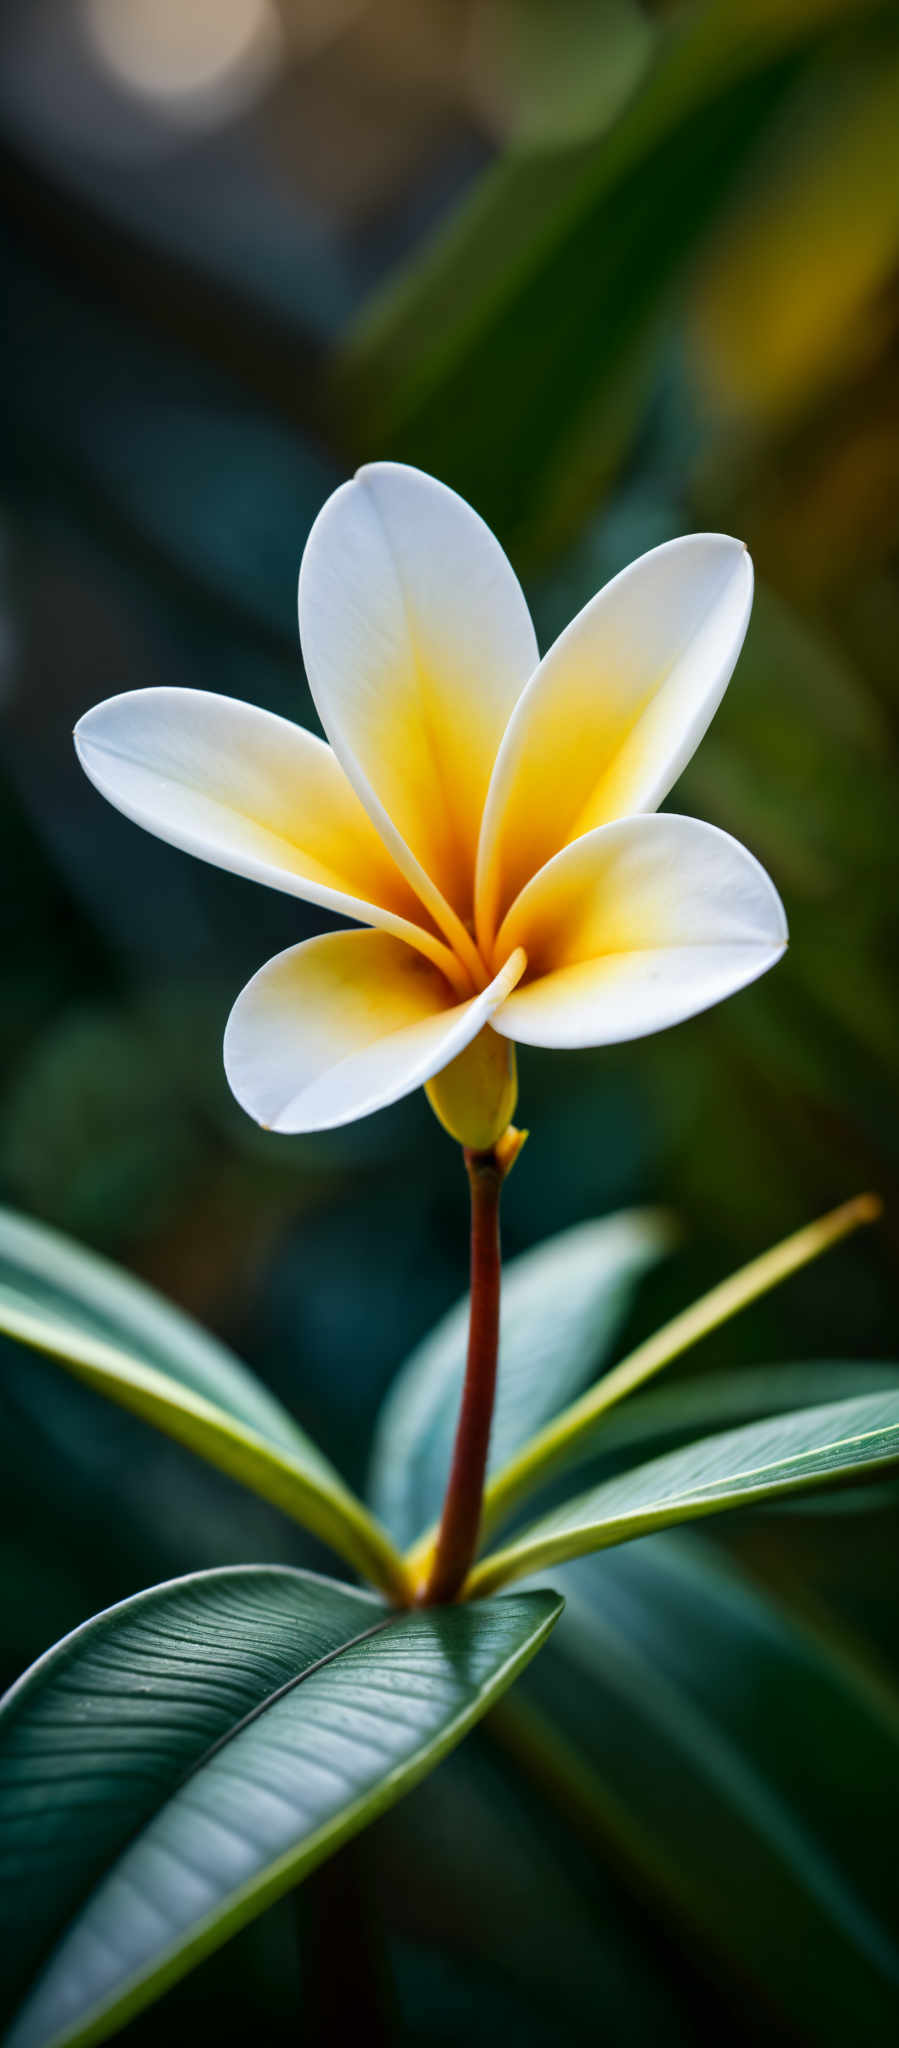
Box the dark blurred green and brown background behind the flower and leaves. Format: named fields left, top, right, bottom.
left=0, top=0, right=899, bottom=2044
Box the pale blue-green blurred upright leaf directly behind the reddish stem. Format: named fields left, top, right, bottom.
left=371, top=1208, right=674, bottom=1544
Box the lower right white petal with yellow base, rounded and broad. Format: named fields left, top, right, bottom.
left=491, top=813, right=786, bottom=1047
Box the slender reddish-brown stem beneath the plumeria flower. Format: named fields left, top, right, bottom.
left=420, top=1151, right=506, bottom=1608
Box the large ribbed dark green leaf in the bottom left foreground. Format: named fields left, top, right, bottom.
left=0, top=1567, right=561, bottom=2048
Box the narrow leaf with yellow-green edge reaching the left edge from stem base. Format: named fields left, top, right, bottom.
left=0, top=1214, right=405, bottom=1593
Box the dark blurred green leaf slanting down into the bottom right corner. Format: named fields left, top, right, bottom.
left=499, top=1534, right=899, bottom=2048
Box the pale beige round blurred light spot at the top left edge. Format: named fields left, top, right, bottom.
left=82, top=0, right=283, bottom=115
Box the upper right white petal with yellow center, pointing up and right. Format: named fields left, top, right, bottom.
left=477, top=532, right=752, bottom=950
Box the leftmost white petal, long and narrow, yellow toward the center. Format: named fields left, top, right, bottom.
left=76, top=690, right=460, bottom=983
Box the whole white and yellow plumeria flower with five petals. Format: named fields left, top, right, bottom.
left=76, top=463, right=786, bottom=1149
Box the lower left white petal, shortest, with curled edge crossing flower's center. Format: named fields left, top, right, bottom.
left=225, top=932, right=524, bottom=1130
